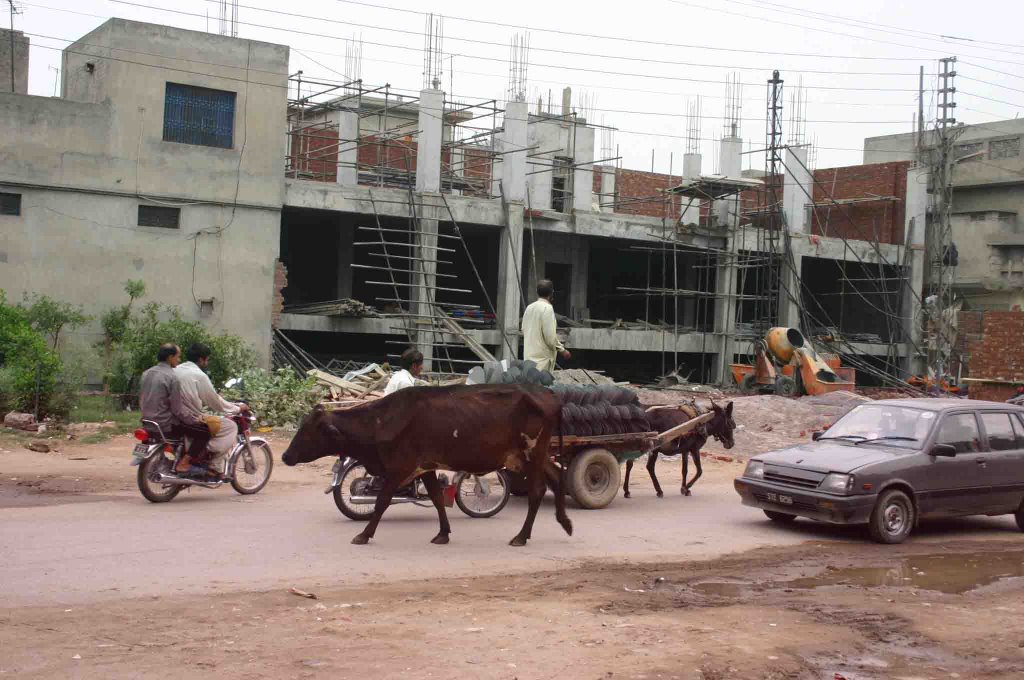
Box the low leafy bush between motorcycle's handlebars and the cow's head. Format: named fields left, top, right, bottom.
left=224, top=369, right=324, bottom=426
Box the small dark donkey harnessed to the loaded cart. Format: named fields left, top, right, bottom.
left=623, top=401, right=736, bottom=498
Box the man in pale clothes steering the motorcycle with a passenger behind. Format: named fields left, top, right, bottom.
left=174, top=342, right=249, bottom=473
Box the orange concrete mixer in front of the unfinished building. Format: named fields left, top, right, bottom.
left=731, top=327, right=856, bottom=396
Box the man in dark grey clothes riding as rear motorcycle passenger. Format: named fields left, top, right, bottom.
left=138, top=342, right=210, bottom=474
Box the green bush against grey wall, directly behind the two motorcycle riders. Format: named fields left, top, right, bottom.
left=109, top=303, right=253, bottom=394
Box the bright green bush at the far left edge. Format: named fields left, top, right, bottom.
left=0, top=291, right=70, bottom=418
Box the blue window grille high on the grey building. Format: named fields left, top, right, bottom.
left=164, top=83, right=234, bottom=148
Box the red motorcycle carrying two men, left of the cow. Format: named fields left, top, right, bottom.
left=131, top=405, right=273, bottom=503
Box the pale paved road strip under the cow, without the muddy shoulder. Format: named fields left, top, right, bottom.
left=0, top=466, right=1016, bottom=606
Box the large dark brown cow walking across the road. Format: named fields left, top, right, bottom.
left=282, top=385, right=572, bottom=546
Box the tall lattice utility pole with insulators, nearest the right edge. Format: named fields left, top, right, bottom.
left=926, top=56, right=963, bottom=385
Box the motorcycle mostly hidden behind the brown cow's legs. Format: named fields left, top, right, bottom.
left=324, top=457, right=511, bottom=521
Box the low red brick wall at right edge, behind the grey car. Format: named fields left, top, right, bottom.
left=968, top=311, right=1024, bottom=401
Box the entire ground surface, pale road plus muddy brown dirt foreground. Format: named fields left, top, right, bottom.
left=0, top=432, right=1024, bottom=680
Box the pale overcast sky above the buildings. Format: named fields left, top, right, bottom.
left=14, top=0, right=1024, bottom=174
